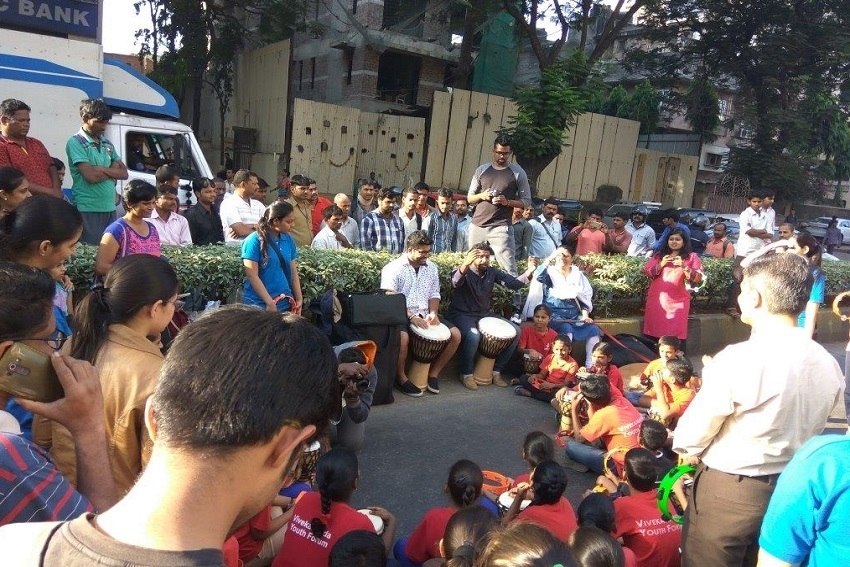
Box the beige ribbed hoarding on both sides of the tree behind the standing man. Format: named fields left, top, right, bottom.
left=425, top=89, right=640, bottom=201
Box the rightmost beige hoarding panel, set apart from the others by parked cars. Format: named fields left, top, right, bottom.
left=623, top=148, right=699, bottom=207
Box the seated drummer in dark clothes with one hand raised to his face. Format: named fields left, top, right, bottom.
left=446, top=242, right=537, bottom=390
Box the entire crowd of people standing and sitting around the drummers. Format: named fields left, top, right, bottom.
left=0, top=100, right=850, bottom=567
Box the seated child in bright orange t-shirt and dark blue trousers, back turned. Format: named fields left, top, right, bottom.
left=564, top=374, right=643, bottom=473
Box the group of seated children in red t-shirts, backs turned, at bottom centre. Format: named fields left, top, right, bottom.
left=394, top=430, right=681, bottom=567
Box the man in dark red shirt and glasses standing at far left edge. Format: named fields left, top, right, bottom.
left=0, top=98, right=62, bottom=197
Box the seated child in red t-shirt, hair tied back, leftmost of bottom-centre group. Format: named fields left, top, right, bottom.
left=393, top=459, right=484, bottom=564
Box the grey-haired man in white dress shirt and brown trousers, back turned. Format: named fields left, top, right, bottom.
left=673, top=254, right=844, bottom=567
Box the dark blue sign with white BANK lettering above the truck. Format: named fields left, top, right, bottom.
left=0, top=0, right=98, bottom=37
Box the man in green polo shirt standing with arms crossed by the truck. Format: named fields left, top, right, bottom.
left=65, top=99, right=128, bottom=245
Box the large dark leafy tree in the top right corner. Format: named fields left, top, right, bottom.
left=632, top=0, right=850, bottom=201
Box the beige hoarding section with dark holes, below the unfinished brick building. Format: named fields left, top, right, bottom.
left=289, top=99, right=425, bottom=193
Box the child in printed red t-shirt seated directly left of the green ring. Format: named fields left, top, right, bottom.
left=614, top=448, right=682, bottom=567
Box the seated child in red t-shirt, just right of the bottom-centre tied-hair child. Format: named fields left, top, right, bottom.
left=502, top=461, right=578, bottom=542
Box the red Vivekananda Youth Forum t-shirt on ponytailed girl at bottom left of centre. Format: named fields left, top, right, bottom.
left=272, top=492, right=375, bottom=567
